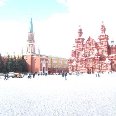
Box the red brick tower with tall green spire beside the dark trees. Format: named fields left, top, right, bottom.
left=24, top=19, right=48, bottom=74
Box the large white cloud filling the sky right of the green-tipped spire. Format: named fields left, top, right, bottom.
left=38, top=0, right=116, bottom=57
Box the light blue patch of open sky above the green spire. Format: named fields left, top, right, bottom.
left=0, top=0, right=67, bottom=20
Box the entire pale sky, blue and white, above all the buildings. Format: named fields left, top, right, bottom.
left=0, top=0, right=116, bottom=58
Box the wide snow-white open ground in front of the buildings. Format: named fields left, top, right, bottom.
left=0, top=73, right=116, bottom=116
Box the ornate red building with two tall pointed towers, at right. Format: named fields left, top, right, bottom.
left=68, top=23, right=116, bottom=73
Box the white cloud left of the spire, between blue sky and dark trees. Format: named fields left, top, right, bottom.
left=0, top=21, right=28, bottom=54
